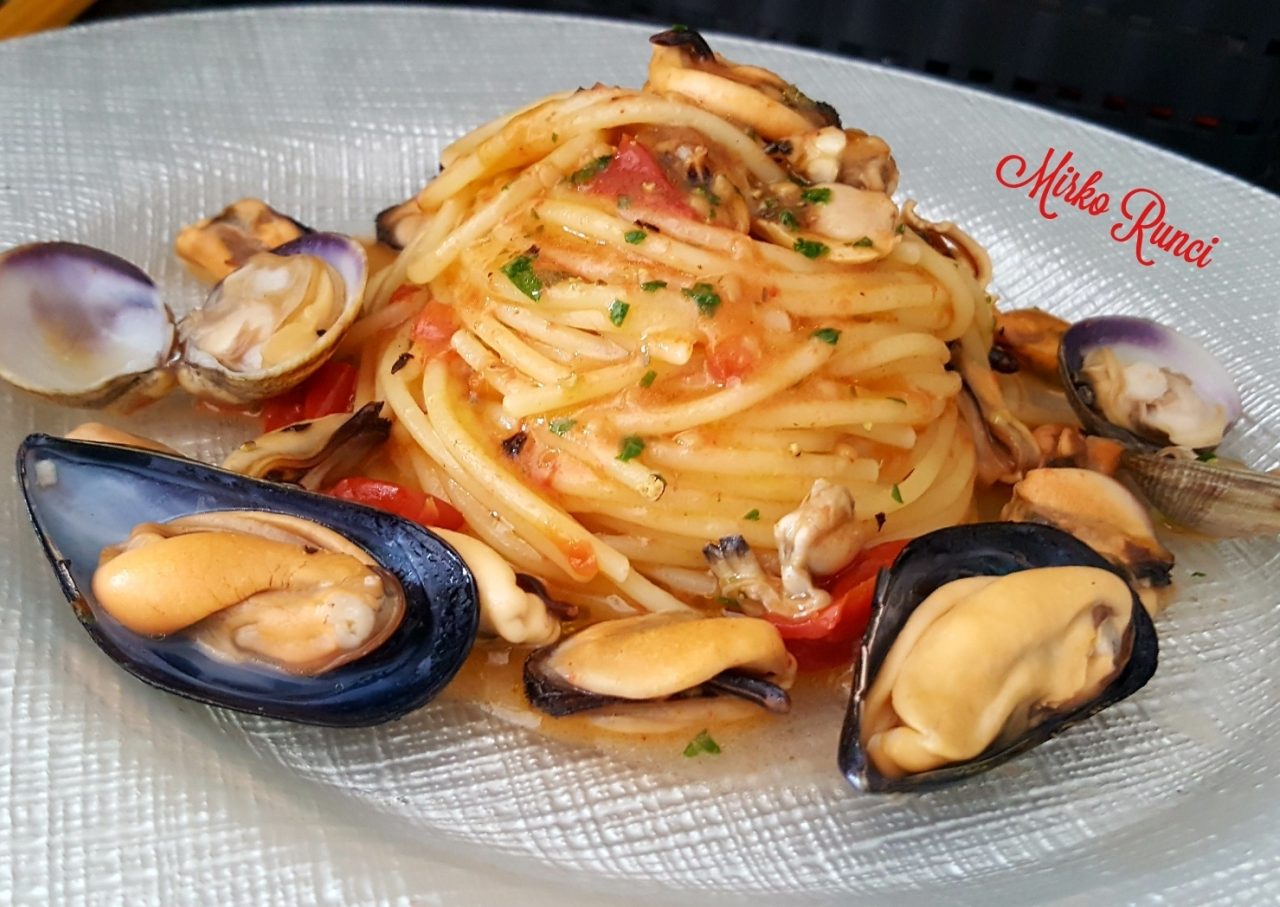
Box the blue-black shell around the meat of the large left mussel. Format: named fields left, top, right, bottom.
left=18, top=435, right=479, bottom=727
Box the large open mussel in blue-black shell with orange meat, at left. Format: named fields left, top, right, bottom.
left=18, top=435, right=479, bottom=727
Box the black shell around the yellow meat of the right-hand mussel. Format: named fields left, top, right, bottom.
left=838, top=523, right=1157, bottom=793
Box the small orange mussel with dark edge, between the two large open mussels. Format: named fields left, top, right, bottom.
left=525, top=613, right=795, bottom=716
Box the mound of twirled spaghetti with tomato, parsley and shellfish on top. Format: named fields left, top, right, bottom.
left=347, top=32, right=993, bottom=611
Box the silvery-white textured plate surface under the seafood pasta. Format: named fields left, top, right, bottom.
left=0, top=6, right=1280, bottom=904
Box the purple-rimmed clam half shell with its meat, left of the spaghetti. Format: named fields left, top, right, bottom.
left=178, top=233, right=369, bottom=403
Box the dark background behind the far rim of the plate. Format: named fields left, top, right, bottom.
left=81, top=0, right=1280, bottom=192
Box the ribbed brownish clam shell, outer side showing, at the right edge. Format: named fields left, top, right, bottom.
left=1121, top=452, right=1280, bottom=539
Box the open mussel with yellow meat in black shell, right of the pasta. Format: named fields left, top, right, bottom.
left=838, top=523, right=1157, bottom=793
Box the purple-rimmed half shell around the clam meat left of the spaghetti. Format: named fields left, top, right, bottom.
left=178, top=233, right=369, bottom=403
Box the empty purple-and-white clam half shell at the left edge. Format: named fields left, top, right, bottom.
left=0, top=242, right=174, bottom=408
